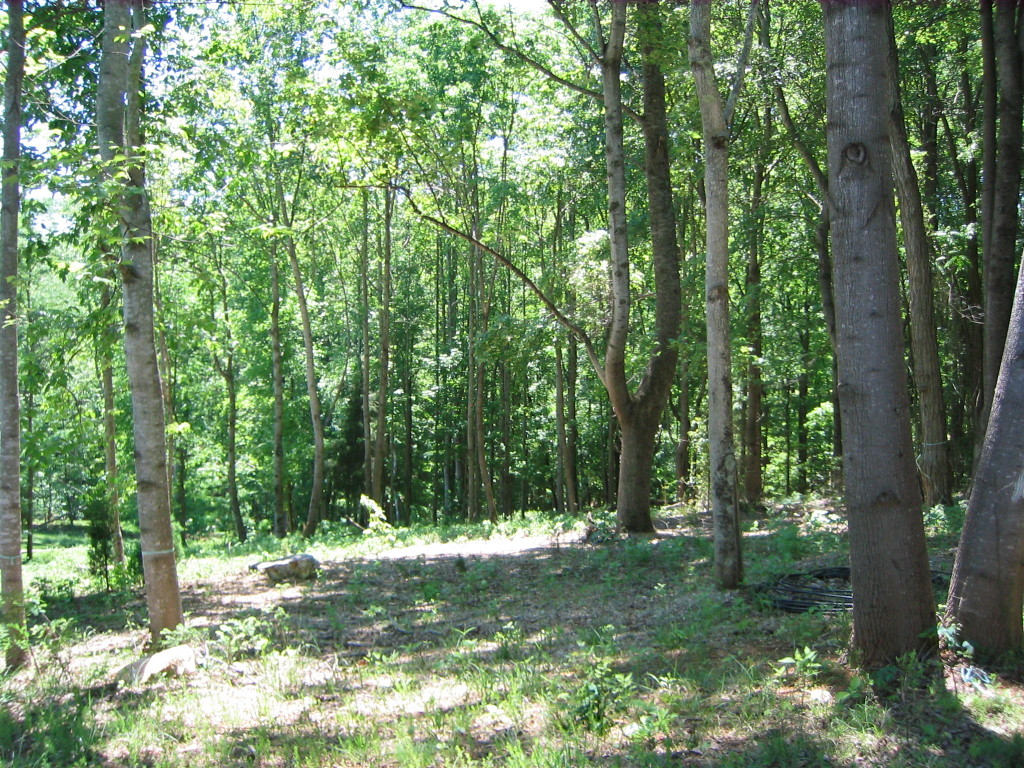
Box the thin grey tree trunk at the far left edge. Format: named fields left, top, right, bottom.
left=0, top=0, right=29, bottom=668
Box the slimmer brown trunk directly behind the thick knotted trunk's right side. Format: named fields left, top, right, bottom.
left=887, top=12, right=952, bottom=508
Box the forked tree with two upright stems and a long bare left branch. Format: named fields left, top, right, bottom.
left=406, top=0, right=680, bottom=532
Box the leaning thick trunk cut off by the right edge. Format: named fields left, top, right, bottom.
left=946, top=262, right=1024, bottom=655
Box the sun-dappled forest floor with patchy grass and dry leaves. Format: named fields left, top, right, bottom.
left=0, top=502, right=1024, bottom=768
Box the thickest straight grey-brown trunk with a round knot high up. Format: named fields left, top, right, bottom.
left=824, top=0, right=936, bottom=668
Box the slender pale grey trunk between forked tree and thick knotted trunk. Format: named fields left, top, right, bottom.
left=689, top=0, right=743, bottom=589
